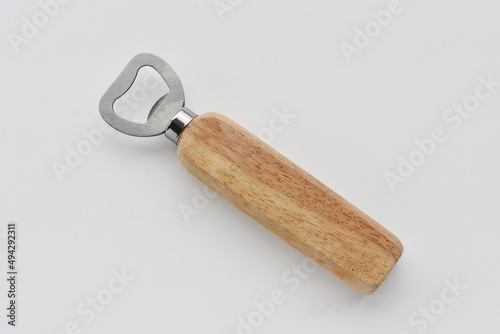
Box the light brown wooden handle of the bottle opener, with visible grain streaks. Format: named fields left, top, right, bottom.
left=178, top=113, right=403, bottom=294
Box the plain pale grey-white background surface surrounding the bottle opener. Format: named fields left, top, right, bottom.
left=0, top=0, right=500, bottom=334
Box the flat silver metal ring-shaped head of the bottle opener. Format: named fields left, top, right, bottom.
left=99, top=53, right=197, bottom=144
